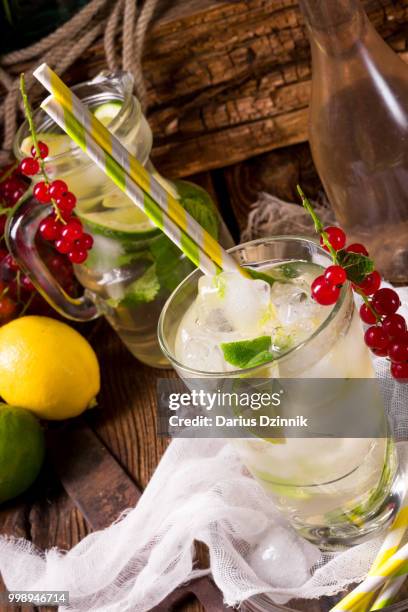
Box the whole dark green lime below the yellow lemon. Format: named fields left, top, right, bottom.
left=0, top=404, right=45, bottom=503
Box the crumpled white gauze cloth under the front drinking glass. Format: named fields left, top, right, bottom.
left=0, top=197, right=408, bottom=612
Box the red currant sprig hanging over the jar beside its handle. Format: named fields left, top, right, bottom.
left=20, top=142, right=93, bottom=264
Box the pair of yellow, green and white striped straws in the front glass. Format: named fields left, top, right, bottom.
left=33, top=64, right=249, bottom=276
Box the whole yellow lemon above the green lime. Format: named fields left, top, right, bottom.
left=0, top=316, right=100, bottom=420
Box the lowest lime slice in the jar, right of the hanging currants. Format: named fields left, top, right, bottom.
left=78, top=206, right=158, bottom=237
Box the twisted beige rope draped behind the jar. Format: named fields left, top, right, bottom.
left=0, top=0, right=159, bottom=152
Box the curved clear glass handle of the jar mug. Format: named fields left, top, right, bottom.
left=6, top=198, right=100, bottom=321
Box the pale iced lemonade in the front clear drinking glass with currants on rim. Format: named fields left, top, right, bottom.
left=159, top=238, right=399, bottom=548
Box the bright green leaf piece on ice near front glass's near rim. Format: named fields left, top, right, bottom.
left=220, top=336, right=273, bottom=368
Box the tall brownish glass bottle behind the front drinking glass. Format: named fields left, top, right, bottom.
left=300, top=0, right=408, bottom=282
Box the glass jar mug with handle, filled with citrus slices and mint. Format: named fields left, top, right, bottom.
left=7, top=73, right=232, bottom=367
